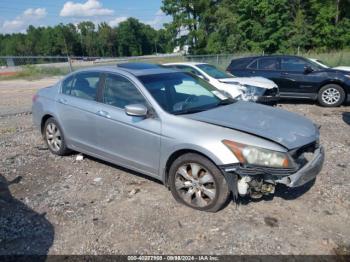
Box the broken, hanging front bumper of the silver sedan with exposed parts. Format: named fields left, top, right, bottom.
left=221, top=147, right=325, bottom=196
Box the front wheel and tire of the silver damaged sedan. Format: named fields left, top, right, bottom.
left=169, top=153, right=230, bottom=212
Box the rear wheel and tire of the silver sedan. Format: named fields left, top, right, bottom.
left=43, top=117, right=71, bottom=156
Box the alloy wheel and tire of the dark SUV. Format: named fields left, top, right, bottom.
left=318, top=84, right=345, bottom=107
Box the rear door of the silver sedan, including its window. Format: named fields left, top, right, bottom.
left=56, top=71, right=100, bottom=152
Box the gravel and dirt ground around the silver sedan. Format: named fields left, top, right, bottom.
left=0, top=79, right=350, bottom=254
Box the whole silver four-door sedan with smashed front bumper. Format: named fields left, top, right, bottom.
left=32, top=66, right=324, bottom=212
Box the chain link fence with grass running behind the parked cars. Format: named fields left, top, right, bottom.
left=0, top=51, right=350, bottom=79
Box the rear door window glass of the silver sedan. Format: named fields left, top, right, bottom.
left=70, top=72, right=100, bottom=100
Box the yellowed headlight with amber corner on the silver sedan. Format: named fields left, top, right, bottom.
left=222, top=140, right=294, bottom=168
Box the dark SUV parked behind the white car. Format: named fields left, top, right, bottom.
left=227, top=55, right=350, bottom=107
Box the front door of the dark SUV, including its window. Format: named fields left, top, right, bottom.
left=279, top=57, right=322, bottom=97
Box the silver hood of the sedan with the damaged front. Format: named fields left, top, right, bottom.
left=184, top=101, right=319, bottom=150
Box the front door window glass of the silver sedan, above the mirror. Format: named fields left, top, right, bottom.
left=103, top=75, right=146, bottom=108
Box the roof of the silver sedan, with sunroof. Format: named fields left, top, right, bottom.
left=72, top=64, right=179, bottom=76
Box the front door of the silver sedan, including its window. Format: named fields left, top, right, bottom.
left=96, top=74, right=161, bottom=176
